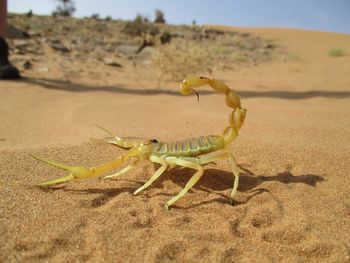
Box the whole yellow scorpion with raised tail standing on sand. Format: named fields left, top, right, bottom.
left=31, top=76, right=247, bottom=209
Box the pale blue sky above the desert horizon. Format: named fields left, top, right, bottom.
left=8, top=0, right=350, bottom=34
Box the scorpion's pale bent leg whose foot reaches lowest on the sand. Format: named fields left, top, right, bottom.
left=165, top=158, right=204, bottom=209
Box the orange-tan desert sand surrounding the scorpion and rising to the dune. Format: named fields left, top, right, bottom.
left=0, top=28, right=350, bottom=262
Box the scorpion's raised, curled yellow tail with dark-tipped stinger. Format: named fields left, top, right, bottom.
left=180, top=76, right=247, bottom=145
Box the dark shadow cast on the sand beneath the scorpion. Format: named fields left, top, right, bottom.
left=45, top=166, right=324, bottom=209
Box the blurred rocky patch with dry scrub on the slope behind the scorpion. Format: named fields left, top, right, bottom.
left=9, top=15, right=278, bottom=85
